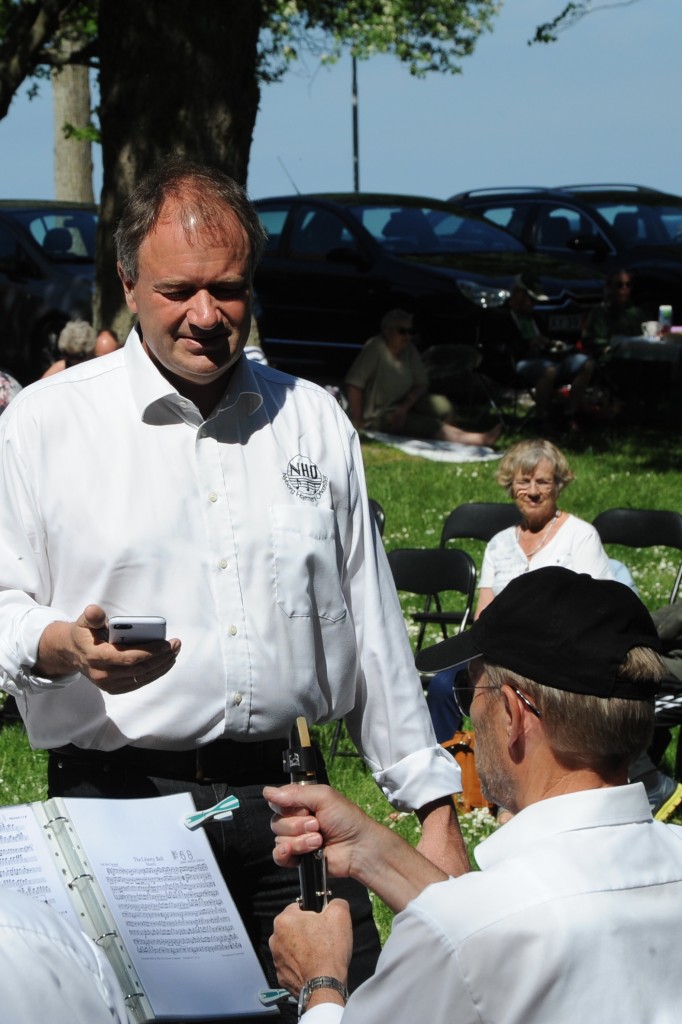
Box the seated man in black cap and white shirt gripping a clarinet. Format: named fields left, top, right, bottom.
left=265, top=566, right=682, bottom=1024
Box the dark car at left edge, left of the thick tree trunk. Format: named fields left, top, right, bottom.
left=0, top=200, right=97, bottom=384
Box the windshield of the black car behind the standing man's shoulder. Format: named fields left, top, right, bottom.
left=350, top=203, right=525, bottom=255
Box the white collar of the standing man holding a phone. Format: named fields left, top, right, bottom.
left=123, top=325, right=263, bottom=423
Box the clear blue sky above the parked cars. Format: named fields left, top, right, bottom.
left=0, top=0, right=682, bottom=199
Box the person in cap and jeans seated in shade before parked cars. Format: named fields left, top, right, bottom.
left=507, top=273, right=594, bottom=429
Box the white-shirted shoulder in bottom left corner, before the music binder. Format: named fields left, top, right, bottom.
left=0, top=888, right=128, bottom=1024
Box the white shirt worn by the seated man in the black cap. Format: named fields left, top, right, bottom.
left=303, top=783, right=682, bottom=1024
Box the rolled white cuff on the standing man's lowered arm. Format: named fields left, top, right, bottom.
left=373, top=745, right=462, bottom=811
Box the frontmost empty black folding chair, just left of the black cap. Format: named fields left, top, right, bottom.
left=388, top=548, right=476, bottom=650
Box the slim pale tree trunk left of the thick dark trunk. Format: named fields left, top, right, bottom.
left=50, top=40, right=94, bottom=203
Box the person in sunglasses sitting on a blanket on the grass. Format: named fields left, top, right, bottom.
left=345, top=309, right=502, bottom=444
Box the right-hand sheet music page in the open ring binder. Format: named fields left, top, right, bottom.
left=63, top=794, right=274, bottom=1018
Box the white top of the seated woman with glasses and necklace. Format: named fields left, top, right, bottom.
left=478, top=515, right=613, bottom=597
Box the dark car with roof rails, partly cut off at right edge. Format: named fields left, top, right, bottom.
left=453, top=184, right=682, bottom=323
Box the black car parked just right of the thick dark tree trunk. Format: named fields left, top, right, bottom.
left=250, top=193, right=603, bottom=380
